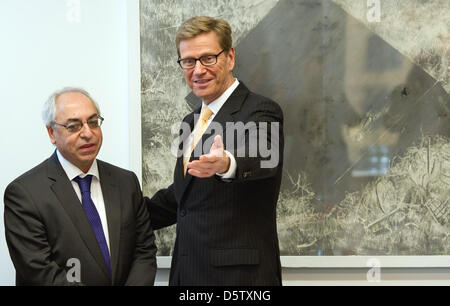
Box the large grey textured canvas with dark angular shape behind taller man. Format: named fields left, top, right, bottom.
left=140, top=0, right=450, bottom=256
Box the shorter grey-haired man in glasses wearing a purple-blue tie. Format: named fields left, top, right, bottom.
left=4, top=88, right=156, bottom=286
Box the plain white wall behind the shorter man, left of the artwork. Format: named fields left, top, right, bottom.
left=0, top=0, right=130, bottom=285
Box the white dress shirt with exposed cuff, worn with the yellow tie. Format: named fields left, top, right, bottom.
left=184, top=79, right=239, bottom=179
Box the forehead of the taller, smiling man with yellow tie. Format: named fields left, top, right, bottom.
left=180, top=32, right=221, bottom=57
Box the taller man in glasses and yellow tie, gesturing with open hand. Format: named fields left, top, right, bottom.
left=146, top=17, right=283, bottom=286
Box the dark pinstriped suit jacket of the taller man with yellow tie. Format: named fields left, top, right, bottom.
left=146, top=83, right=283, bottom=285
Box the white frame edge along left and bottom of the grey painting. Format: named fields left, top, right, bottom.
left=127, top=0, right=450, bottom=268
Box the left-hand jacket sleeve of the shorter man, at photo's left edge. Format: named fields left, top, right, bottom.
left=4, top=182, right=80, bottom=285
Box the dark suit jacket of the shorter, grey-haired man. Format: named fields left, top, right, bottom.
left=4, top=151, right=156, bottom=285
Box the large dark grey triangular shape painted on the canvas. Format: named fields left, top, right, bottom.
left=230, top=0, right=450, bottom=207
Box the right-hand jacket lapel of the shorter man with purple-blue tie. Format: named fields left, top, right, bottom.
left=97, top=160, right=122, bottom=284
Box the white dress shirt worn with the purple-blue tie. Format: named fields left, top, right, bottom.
left=56, top=150, right=110, bottom=250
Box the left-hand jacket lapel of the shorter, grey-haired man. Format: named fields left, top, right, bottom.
left=48, top=151, right=109, bottom=278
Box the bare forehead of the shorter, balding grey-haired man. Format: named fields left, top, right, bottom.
left=55, top=92, right=97, bottom=120
